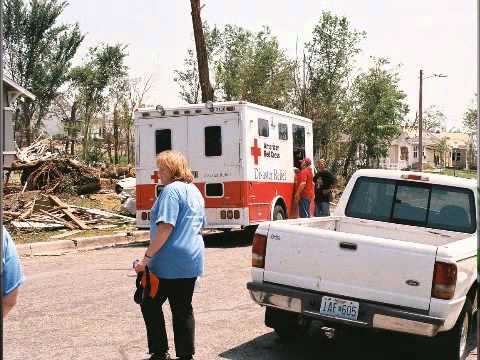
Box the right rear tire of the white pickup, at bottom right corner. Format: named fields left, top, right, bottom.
left=433, top=299, right=473, bottom=360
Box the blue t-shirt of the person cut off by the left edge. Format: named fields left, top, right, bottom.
left=2, top=227, right=24, bottom=296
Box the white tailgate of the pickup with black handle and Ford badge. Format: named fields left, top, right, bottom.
left=264, top=223, right=437, bottom=310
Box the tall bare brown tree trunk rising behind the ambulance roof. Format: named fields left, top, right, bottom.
left=190, top=0, right=213, bottom=102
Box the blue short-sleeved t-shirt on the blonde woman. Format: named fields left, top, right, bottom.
left=149, top=181, right=205, bottom=279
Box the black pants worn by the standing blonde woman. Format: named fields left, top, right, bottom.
left=141, top=278, right=196, bottom=357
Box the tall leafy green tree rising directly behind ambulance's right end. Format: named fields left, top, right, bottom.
left=302, top=11, right=365, bottom=158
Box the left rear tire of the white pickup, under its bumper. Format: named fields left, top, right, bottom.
left=265, top=307, right=311, bottom=341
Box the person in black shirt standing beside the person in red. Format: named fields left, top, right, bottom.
left=313, top=159, right=335, bottom=216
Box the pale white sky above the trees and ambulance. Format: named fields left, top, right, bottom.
left=58, top=0, right=477, bottom=127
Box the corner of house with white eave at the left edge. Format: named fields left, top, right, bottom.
left=2, top=76, right=35, bottom=168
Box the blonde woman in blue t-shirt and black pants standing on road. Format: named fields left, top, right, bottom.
left=135, top=151, right=205, bottom=360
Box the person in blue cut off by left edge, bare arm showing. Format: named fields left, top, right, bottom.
left=2, top=227, right=24, bottom=318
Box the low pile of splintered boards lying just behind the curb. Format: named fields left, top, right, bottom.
left=3, top=191, right=135, bottom=231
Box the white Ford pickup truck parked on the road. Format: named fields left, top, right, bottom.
left=247, top=170, right=477, bottom=360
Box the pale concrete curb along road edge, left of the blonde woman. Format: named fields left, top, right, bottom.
left=17, top=231, right=150, bottom=256
